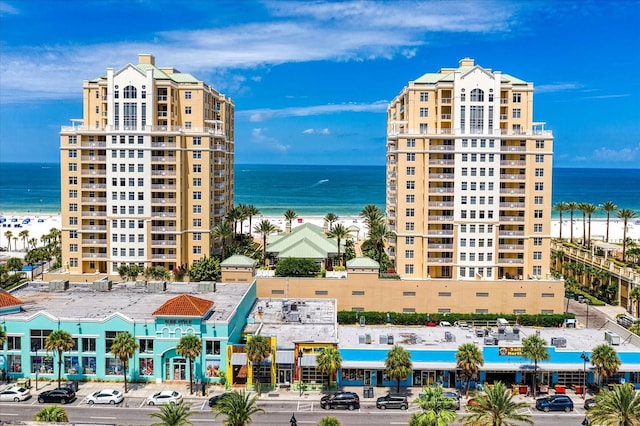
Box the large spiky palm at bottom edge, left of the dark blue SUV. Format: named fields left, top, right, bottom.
left=464, top=382, right=533, bottom=426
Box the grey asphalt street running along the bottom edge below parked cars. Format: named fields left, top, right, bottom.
left=0, top=398, right=584, bottom=426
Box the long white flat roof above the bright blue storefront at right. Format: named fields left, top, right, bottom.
left=338, top=325, right=640, bottom=352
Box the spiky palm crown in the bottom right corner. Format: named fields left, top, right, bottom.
left=587, top=385, right=640, bottom=426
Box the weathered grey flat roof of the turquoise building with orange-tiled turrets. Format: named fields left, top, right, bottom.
left=6, top=282, right=251, bottom=322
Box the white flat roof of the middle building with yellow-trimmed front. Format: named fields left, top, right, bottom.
left=244, top=298, right=338, bottom=349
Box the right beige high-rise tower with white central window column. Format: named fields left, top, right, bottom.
left=386, top=58, right=553, bottom=281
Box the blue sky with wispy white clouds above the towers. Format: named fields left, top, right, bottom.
left=0, top=0, right=640, bottom=168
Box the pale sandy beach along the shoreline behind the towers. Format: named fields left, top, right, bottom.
left=0, top=212, right=640, bottom=256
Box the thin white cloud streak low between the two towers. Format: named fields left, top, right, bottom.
left=242, top=100, right=389, bottom=122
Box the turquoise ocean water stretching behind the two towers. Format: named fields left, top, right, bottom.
left=0, top=163, right=640, bottom=216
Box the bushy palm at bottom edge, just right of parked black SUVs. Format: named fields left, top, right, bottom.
left=409, top=386, right=456, bottom=426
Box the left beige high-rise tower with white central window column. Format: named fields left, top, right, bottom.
left=60, top=54, right=234, bottom=274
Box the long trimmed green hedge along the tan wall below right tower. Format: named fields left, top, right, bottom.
left=338, top=311, right=575, bottom=327
